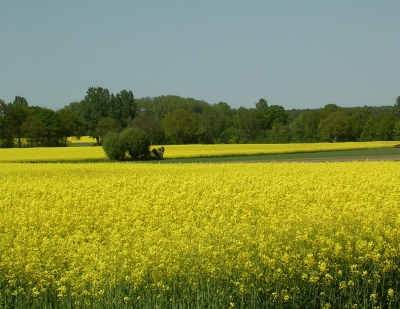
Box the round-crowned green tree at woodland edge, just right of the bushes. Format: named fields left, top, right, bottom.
left=161, top=109, right=198, bottom=144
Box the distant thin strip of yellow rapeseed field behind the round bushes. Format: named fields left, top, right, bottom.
left=0, top=138, right=400, bottom=162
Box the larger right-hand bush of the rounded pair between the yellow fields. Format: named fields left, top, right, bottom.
left=119, top=128, right=150, bottom=159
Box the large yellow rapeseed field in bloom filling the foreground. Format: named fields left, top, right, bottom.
left=0, top=162, right=400, bottom=308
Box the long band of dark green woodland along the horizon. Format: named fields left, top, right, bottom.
left=0, top=87, right=400, bottom=148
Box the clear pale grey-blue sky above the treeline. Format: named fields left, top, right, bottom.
left=0, top=0, right=400, bottom=110
